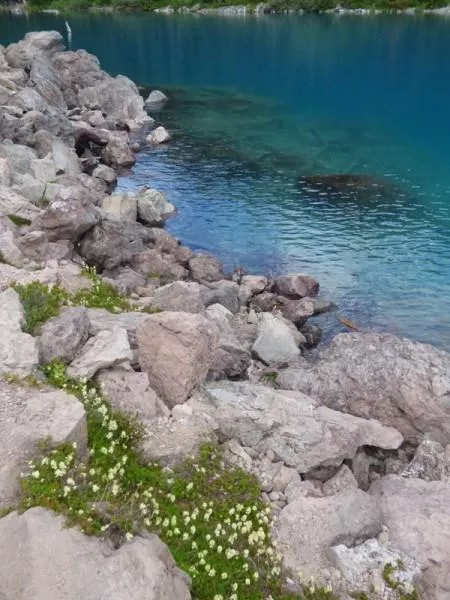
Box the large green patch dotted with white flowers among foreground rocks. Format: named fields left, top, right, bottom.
left=21, top=362, right=316, bottom=600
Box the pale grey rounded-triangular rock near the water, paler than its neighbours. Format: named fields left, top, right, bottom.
left=252, top=313, right=300, bottom=366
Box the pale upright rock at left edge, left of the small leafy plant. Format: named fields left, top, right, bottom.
left=0, top=288, right=39, bottom=377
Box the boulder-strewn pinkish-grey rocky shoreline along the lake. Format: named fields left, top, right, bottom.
left=0, top=32, right=450, bottom=600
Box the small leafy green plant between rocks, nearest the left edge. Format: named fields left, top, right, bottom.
left=13, top=281, right=68, bottom=334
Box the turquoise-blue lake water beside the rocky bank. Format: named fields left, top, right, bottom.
left=0, top=15, right=450, bottom=350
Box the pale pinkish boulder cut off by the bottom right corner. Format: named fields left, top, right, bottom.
left=371, top=475, right=450, bottom=600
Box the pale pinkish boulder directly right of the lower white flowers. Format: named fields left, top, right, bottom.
left=274, top=490, right=381, bottom=580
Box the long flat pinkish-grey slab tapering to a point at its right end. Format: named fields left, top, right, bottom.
left=188, top=382, right=403, bottom=473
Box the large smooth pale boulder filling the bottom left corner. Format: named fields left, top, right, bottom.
left=0, top=508, right=191, bottom=600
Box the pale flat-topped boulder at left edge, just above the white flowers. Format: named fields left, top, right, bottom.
left=0, top=379, right=87, bottom=506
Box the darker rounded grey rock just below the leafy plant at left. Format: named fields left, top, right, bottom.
left=38, top=307, right=89, bottom=364
